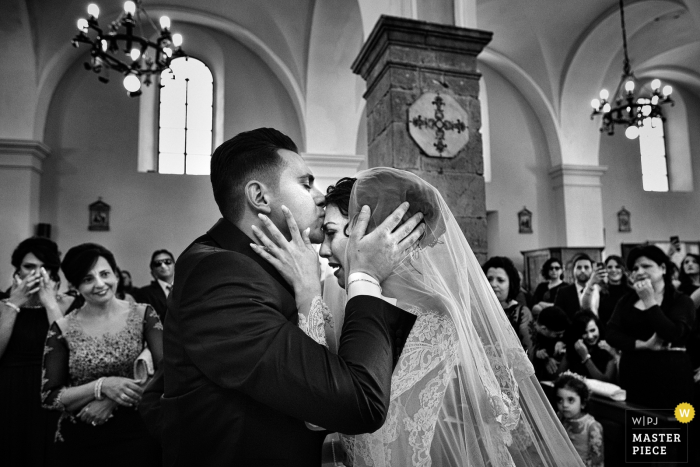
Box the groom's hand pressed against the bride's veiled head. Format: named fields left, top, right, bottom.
left=347, top=202, right=425, bottom=283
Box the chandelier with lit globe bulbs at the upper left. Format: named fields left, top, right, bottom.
left=72, top=0, right=185, bottom=97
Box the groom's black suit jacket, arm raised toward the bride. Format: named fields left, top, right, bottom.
left=160, top=219, right=415, bottom=466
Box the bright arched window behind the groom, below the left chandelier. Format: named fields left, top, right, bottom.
left=158, top=57, right=214, bottom=175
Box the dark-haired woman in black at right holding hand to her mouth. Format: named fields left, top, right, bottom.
left=606, top=245, right=695, bottom=409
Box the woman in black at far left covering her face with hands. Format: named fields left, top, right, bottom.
left=0, top=237, right=73, bottom=466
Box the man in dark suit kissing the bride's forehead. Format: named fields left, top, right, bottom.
left=161, top=128, right=423, bottom=466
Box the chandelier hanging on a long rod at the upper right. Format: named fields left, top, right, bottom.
left=591, top=0, right=673, bottom=139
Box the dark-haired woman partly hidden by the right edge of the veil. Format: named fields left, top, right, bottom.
left=482, top=256, right=532, bottom=352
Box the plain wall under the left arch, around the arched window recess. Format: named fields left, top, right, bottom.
left=40, top=32, right=302, bottom=285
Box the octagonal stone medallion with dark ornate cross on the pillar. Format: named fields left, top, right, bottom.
left=408, top=92, right=469, bottom=158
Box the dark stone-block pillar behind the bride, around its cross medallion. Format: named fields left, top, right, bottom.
left=352, top=16, right=492, bottom=260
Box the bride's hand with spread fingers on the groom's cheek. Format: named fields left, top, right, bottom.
left=250, top=206, right=321, bottom=310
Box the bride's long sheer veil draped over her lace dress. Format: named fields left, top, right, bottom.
left=343, top=168, right=583, bottom=467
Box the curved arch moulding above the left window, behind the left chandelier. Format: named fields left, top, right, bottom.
left=34, top=6, right=306, bottom=145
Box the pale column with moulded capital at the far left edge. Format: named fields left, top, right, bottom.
left=0, top=139, right=49, bottom=290
